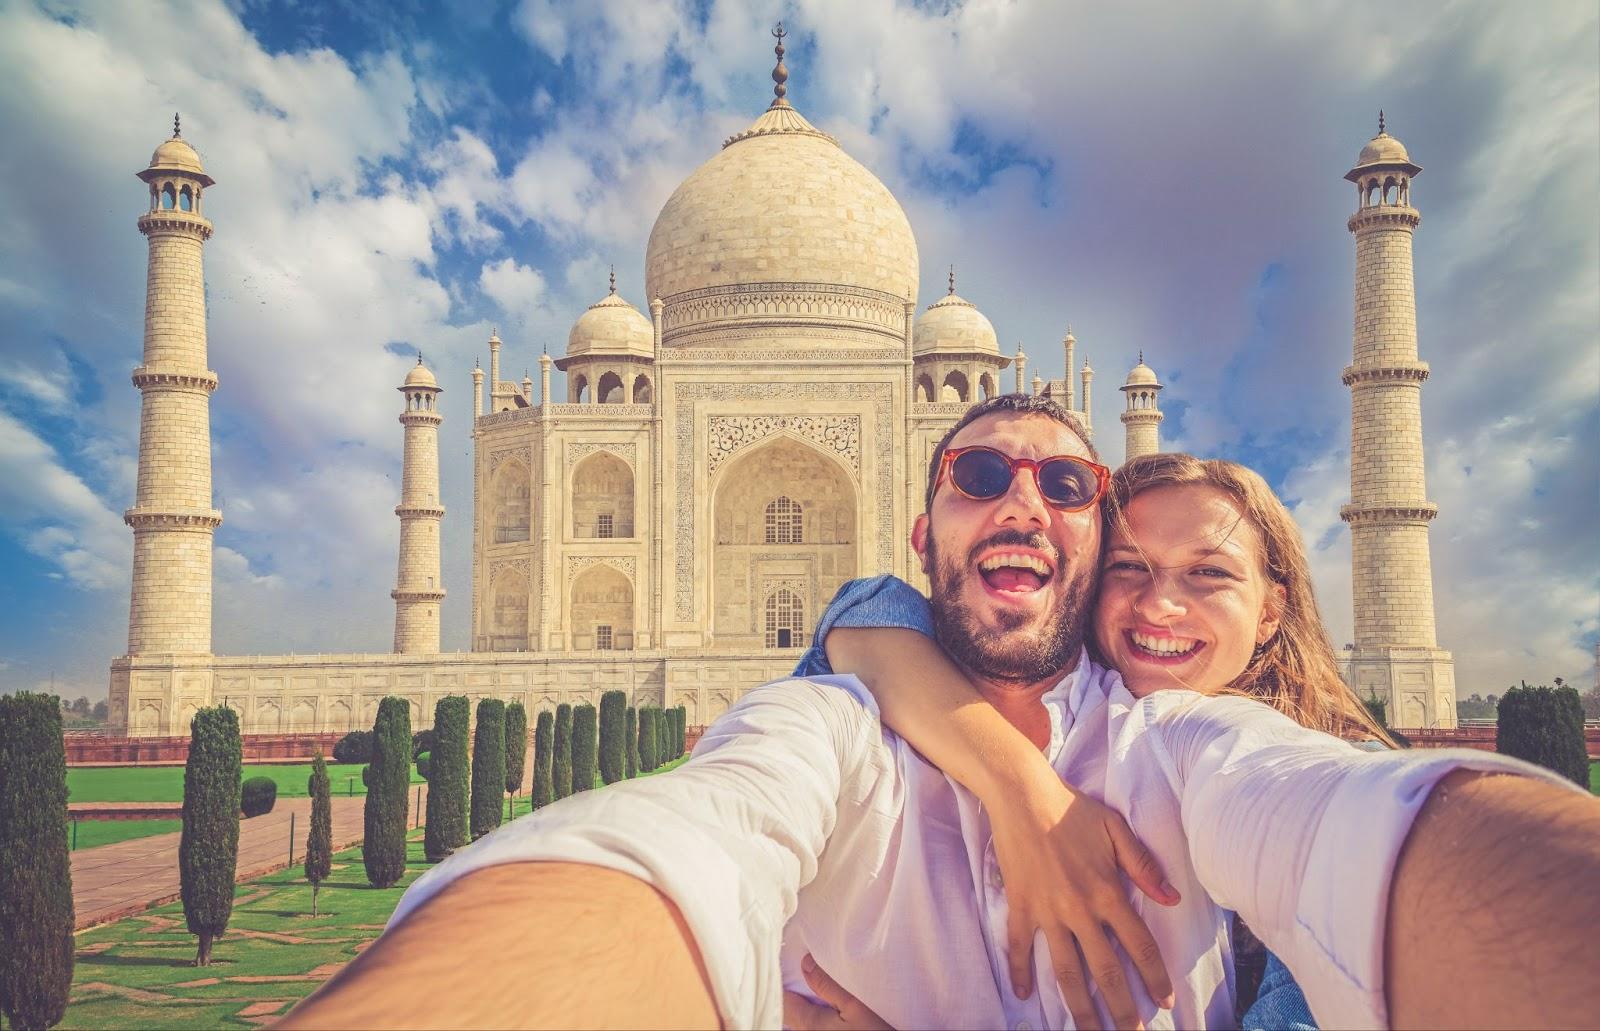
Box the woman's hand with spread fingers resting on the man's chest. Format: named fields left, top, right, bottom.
left=984, top=764, right=1179, bottom=1028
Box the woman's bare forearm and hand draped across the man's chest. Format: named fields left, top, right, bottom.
left=826, top=628, right=1178, bottom=1028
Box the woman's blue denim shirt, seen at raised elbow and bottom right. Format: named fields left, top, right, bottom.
left=795, top=575, right=1317, bottom=1031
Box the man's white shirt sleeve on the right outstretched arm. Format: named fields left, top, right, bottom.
left=1142, top=692, right=1573, bottom=1028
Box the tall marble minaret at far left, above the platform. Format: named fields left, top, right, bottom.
left=123, top=115, right=222, bottom=656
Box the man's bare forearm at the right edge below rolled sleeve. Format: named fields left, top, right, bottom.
left=1384, top=770, right=1600, bottom=1028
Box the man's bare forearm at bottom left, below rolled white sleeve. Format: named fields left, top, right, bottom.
left=277, top=863, right=720, bottom=1028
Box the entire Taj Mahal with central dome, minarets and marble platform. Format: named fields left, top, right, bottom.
left=110, top=35, right=1454, bottom=736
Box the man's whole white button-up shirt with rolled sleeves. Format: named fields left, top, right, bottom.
left=390, top=656, right=1565, bottom=1028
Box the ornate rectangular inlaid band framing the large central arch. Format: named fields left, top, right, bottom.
left=672, top=383, right=894, bottom=621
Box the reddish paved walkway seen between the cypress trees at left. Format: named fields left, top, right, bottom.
left=72, top=784, right=427, bottom=930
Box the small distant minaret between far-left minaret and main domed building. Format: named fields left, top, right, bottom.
left=389, top=355, right=445, bottom=655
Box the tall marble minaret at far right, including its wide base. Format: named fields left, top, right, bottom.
left=1339, top=114, right=1456, bottom=727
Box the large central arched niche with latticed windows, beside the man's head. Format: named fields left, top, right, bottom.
left=709, top=434, right=859, bottom=648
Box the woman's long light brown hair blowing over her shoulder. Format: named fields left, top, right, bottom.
left=1106, top=453, right=1394, bottom=748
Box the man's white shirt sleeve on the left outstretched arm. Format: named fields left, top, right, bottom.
left=389, top=677, right=877, bottom=1028
